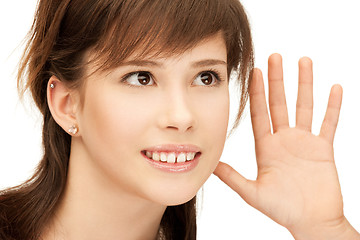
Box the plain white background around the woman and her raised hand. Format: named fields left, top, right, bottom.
left=0, top=0, right=360, bottom=240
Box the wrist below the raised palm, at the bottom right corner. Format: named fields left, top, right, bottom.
left=289, top=217, right=360, bottom=240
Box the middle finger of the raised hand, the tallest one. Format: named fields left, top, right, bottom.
left=268, top=54, right=289, bottom=133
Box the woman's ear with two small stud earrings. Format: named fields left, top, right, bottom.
left=47, top=76, right=79, bottom=136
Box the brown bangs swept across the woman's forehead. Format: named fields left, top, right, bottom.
left=94, top=0, right=234, bottom=70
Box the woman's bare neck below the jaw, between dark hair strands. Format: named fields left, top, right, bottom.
left=42, top=141, right=166, bottom=240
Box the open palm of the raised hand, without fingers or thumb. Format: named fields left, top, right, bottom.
left=255, top=128, right=343, bottom=229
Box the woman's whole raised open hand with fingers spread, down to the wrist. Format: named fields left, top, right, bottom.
left=214, top=54, right=360, bottom=240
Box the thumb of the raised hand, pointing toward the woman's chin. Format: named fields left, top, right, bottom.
left=214, top=162, right=256, bottom=205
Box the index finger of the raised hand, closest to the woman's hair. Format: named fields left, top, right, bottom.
left=250, top=69, right=271, bottom=140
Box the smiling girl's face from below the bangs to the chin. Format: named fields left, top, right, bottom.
left=73, top=34, right=229, bottom=205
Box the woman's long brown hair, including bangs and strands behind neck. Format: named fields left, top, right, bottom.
left=0, top=0, right=253, bottom=240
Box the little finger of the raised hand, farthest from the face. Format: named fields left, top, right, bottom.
left=319, top=84, right=343, bottom=144
